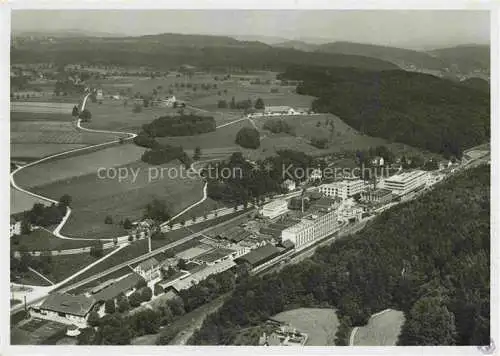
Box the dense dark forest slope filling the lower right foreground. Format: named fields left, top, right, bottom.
left=190, top=166, right=490, bottom=345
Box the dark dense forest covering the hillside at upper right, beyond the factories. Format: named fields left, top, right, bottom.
left=281, top=67, right=490, bottom=157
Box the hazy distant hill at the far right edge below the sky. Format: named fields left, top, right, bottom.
left=429, top=45, right=490, bottom=72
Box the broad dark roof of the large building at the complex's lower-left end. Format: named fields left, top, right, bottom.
left=40, top=293, right=96, bottom=316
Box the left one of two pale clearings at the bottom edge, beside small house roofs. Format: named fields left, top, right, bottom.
left=272, top=308, right=339, bottom=346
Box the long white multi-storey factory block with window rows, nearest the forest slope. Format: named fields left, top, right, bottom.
left=281, top=211, right=339, bottom=249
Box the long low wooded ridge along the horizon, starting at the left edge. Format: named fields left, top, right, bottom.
left=11, top=33, right=397, bottom=71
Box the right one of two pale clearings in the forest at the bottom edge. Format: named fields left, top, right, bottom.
left=353, top=309, right=405, bottom=346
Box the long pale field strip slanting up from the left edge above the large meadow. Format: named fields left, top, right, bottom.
left=15, top=143, right=145, bottom=188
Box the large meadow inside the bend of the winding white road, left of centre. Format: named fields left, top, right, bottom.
left=35, top=161, right=203, bottom=238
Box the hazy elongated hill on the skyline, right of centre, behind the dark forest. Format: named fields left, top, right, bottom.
left=317, top=42, right=446, bottom=70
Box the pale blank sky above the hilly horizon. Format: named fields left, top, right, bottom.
left=11, top=10, right=490, bottom=48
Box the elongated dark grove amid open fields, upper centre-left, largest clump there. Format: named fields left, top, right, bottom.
left=142, top=114, right=216, bottom=137
